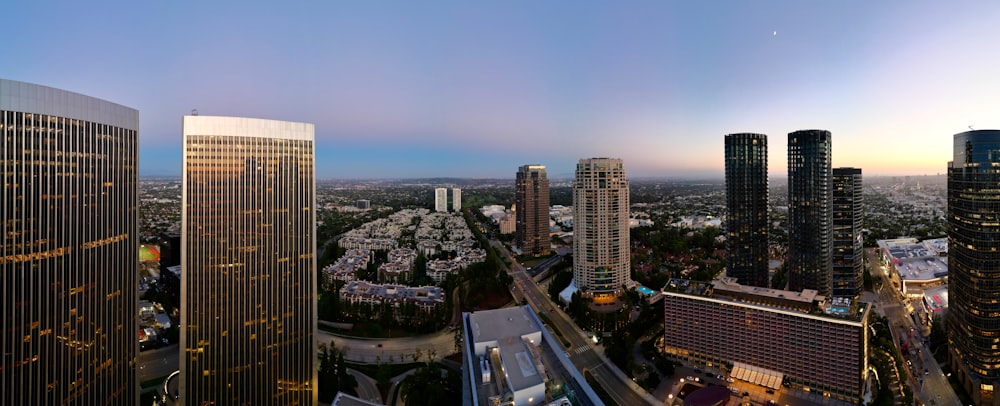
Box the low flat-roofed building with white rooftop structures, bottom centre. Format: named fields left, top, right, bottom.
left=462, top=306, right=604, bottom=406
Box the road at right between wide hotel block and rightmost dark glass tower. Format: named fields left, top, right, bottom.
left=865, top=249, right=961, bottom=406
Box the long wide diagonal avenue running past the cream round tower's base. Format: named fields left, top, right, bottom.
left=490, top=240, right=660, bottom=405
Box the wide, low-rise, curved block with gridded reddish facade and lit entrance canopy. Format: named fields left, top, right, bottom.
left=663, top=277, right=870, bottom=403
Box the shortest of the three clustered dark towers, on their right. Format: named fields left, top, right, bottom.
left=833, top=168, right=864, bottom=298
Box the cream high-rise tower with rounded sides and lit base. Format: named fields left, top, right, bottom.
left=573, top=158, right=631, bottom=296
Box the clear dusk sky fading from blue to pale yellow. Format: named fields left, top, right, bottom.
left=0, top=0, right=1000, bottom=179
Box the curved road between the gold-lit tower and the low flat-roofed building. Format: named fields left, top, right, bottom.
left=316, top=330, right=455, bottom=364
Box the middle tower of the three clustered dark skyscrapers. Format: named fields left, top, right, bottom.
left=787, top=130, right=833, bottom=296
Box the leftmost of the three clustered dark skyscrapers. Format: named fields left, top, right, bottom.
left=726, top=133, right=769, bottom=287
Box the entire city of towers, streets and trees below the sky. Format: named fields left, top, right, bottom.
left=0, top=74, right=1000, bottom=406
